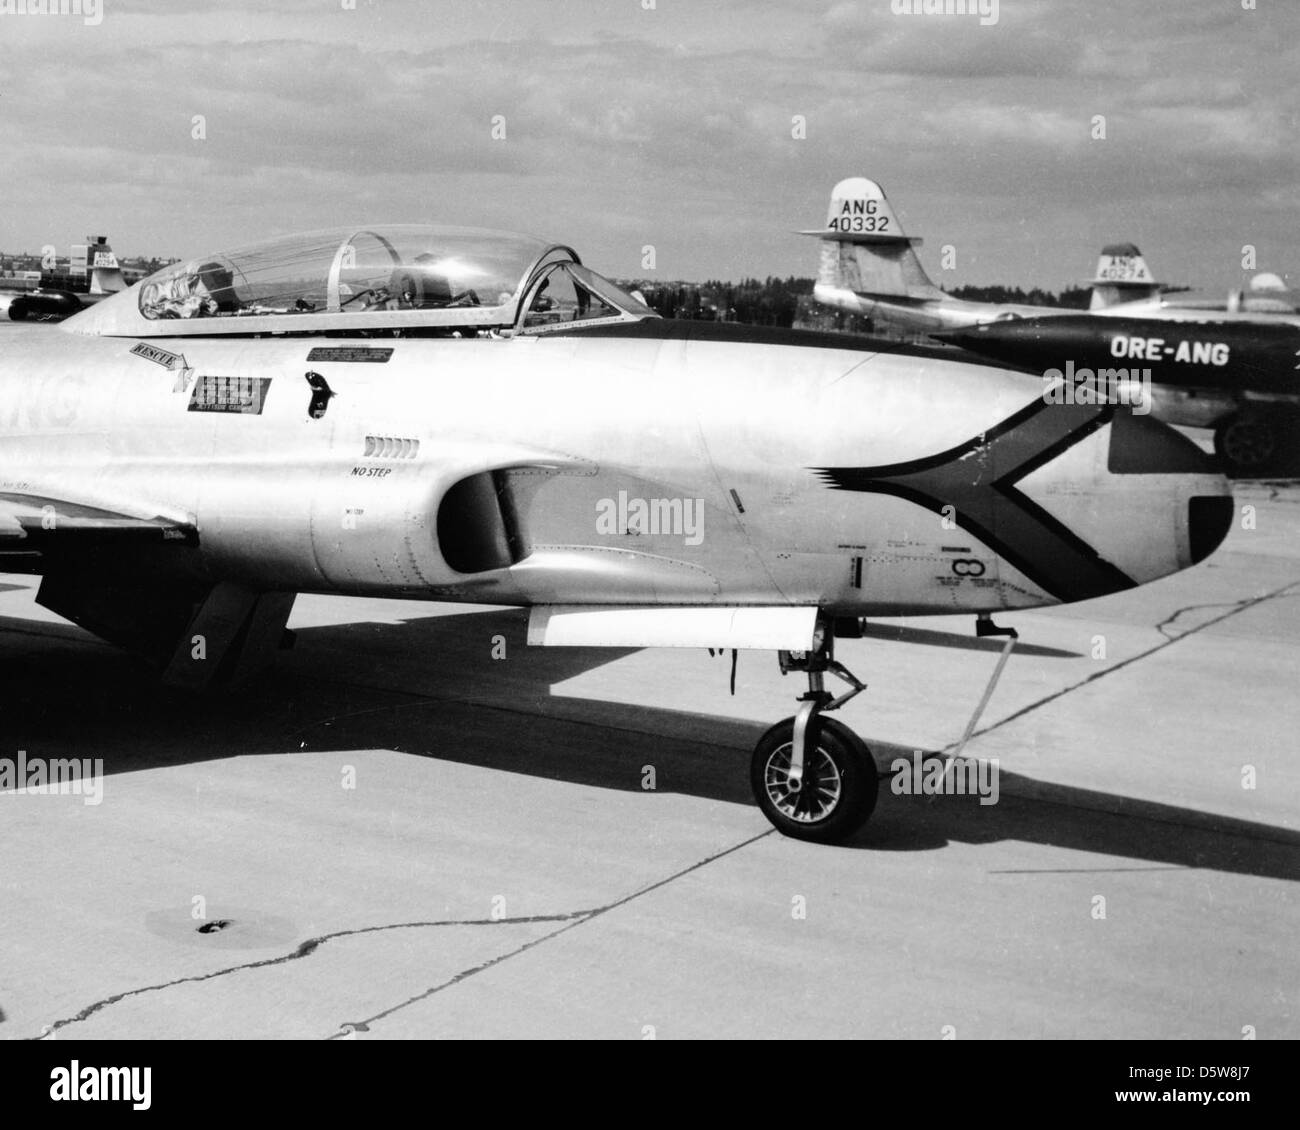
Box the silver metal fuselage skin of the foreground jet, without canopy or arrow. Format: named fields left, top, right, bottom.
left=0, top=317, right=1227, bottom=615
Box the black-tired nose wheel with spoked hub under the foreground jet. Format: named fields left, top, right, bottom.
left=749, top=715, right=880, bottom=844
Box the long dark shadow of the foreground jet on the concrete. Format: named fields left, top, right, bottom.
left=0, top=610, right=1300, bottom=880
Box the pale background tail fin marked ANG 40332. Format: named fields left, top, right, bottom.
left=800, top=177, right=944, bottom=299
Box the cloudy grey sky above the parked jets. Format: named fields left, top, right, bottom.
left=0, top=0, right=1300, bottom=289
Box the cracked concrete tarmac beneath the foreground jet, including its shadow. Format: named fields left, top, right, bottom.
left=0, top=314, right=1300, bottom=1039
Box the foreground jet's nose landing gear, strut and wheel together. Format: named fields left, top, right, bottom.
left=749, top=625, right=880, bottom=844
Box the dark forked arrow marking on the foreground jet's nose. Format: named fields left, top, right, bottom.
left=810, top=401, right=1138, bottom=602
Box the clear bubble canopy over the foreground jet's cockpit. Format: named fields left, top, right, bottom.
left=65, top=225, right=653, bottom=337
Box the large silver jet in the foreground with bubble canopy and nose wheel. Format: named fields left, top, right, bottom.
left=0, top=226, right=1234, bottom=841
